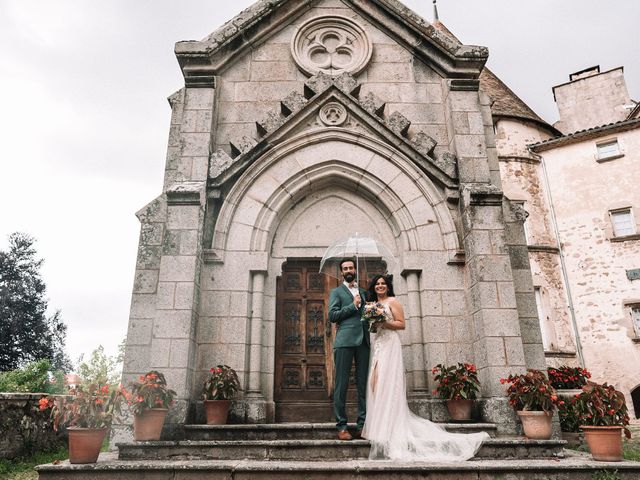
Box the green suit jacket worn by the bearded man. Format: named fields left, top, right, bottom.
left=329, top=284, right=369, bottom=349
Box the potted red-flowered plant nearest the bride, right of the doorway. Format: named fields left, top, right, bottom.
left=431, top=363, right=480, bottom=420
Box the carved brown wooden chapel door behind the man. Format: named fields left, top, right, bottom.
left=274, top=260, right=356, bottom=422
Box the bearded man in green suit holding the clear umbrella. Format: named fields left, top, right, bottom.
left=329, top=258, right=369, bottom=440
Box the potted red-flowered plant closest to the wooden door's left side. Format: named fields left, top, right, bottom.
left=202, top=365, right=240, bottom=425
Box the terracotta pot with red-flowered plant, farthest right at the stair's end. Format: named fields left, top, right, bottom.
left=573, top=382, right=631, bottom=462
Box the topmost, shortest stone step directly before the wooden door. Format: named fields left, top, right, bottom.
left=184, top=422, right=497, bottom=440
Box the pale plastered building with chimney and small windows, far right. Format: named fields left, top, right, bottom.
left=528, top=67, right=640, bottom=418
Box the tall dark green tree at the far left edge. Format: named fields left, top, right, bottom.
left=0, top=233, right=70, bottom=371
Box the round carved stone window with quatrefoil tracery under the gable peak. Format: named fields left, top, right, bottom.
left=291, top=15, right=373, bottom=76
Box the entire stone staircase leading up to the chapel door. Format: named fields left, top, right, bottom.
left=38, top=423, right=640, bottom=480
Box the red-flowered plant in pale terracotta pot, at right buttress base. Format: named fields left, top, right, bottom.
left=500, top=369, right=564, bottom=440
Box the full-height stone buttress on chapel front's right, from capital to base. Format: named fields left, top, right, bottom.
left=446, top=79, right=526, bottom=433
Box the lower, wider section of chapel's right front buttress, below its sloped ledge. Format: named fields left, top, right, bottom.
left=461, top=184, right=527, bottom=433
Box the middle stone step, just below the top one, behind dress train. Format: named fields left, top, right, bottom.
left=116, top=437, right=566, bottom=461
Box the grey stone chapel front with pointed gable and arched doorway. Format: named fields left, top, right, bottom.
left=119, top=0, right=552, bottom=433
